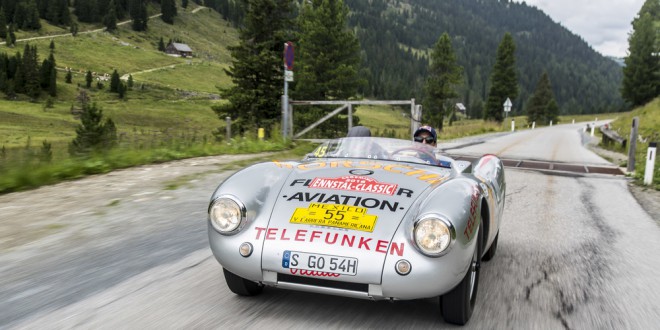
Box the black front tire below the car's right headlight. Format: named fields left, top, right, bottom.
left=440, top=228, right=483, bottom=325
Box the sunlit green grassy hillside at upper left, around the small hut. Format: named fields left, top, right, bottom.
left=0, top=3, right=238, bottom=158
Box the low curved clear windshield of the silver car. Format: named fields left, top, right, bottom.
left=306, top=137, right=440, bottom=165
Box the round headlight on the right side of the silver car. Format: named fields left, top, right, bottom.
left=414, top=217, right=453, bottom=257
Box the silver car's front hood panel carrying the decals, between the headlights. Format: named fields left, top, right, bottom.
left=258, top=159, right=451, bottom=284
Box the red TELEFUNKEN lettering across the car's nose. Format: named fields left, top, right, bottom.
left=254, top=227, right=405, bottom=257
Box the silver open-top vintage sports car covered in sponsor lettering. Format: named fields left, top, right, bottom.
left=208, top=137, right=506, bottom=324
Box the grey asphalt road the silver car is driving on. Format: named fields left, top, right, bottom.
left=0, top=125, right=660, bottom=329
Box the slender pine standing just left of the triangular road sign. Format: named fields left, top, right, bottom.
left=485, top=33, right=518, bottom=122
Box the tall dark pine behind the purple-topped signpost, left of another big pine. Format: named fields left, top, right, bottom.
left=212, top=0, right=292, bottom=132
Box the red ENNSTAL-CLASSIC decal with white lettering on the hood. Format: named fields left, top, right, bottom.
left=309, top=175, right=399, bottom=196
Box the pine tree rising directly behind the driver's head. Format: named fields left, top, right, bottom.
left=423, top=32, right=463, bottom=130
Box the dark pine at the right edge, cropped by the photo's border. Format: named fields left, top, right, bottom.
left=621, top=0, right=660, bottom=106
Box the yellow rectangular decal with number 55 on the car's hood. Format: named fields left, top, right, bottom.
left=289, top=203, right=378, bottom=232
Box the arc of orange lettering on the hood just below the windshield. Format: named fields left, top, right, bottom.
left=273, top=160, right=450, bottom=184
